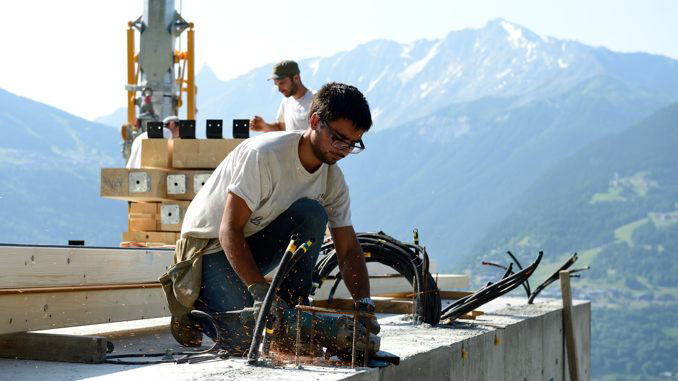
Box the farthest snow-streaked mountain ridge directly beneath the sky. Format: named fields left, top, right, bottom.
left=97, top=19, right=678, bottom=136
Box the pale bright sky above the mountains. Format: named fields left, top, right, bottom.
left=0, top=0, right=678, bottom=119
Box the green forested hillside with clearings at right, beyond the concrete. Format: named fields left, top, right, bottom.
left=462, top=104, right=678, bottom=379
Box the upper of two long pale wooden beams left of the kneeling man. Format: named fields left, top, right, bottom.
left=0, top=245, right=175, bottom=288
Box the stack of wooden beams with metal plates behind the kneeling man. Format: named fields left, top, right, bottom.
left=101, top=135, right=244, bottom=247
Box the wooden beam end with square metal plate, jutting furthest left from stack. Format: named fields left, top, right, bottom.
left=100, top=168, right=167, bottom=201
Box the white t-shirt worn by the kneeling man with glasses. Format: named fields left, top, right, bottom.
left=181, top=131, right=351, bottom=238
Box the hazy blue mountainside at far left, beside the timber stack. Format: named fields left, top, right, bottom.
left=0, top=89, right=127, bottom=246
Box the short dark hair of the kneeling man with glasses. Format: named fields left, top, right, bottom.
left=309, top=82, right=372, bottom=131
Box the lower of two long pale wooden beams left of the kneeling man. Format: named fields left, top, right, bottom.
left=0, top=287, right=169, bottom=334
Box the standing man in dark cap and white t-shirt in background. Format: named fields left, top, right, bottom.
left=250, top=60, right=313, bottom=132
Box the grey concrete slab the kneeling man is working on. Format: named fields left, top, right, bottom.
left=0, top=297, right=590, bottom=381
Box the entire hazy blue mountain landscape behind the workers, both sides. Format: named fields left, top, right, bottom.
left=0, top=19, right=678, bottom=379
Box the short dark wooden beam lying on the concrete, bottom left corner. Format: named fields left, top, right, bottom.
left=0, top=332, right=108, bottom=364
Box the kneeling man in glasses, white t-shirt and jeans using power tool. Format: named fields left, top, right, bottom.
left=170, top=83, right=379, bottom=350
